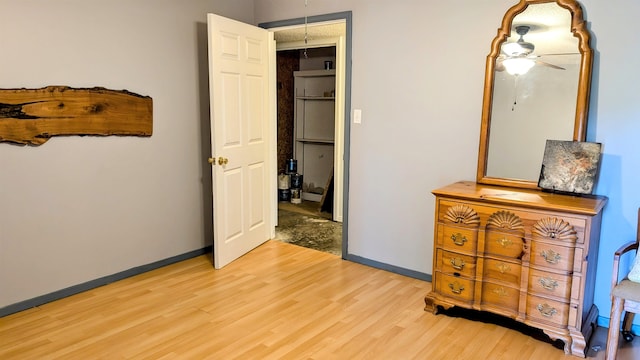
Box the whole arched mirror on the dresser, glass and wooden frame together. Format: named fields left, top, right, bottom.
left=477, top=0, right=593, bottom=189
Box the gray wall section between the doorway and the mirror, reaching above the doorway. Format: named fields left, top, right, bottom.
left=255, top=0, right=513, bottom=274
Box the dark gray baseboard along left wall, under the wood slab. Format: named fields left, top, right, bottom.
left=0, top=246, right=212, bottom=317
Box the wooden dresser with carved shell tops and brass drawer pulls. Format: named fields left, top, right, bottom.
left=425, top=181, right=607, bottom=357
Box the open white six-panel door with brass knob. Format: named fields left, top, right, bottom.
left=207, top=14, right=273, bottom=269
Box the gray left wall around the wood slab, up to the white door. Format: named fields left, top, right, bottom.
left=0, top=0, right=253, bottom=308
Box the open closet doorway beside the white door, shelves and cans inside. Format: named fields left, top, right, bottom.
left=268, top=13, right=350, bottom=258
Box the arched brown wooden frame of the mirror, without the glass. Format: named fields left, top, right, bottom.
left=476, top=0, right=593, bottom=189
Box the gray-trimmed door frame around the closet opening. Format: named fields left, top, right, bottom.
left=258, top=11, right=352, bottom=259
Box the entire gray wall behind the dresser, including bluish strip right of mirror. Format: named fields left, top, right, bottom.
left=255, top=0, right=640, bottom=325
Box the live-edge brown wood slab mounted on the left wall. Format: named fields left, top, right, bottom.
left=0, top=86, right=153, bottom=145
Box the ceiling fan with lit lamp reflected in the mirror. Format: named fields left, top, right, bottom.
left=496, top=25, right=565, bottom=76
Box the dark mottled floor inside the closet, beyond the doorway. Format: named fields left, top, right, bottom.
left=276, top=201, right=342, bottom=256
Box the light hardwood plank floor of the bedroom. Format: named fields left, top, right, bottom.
left=0, top=241, right=640, bottom=360
